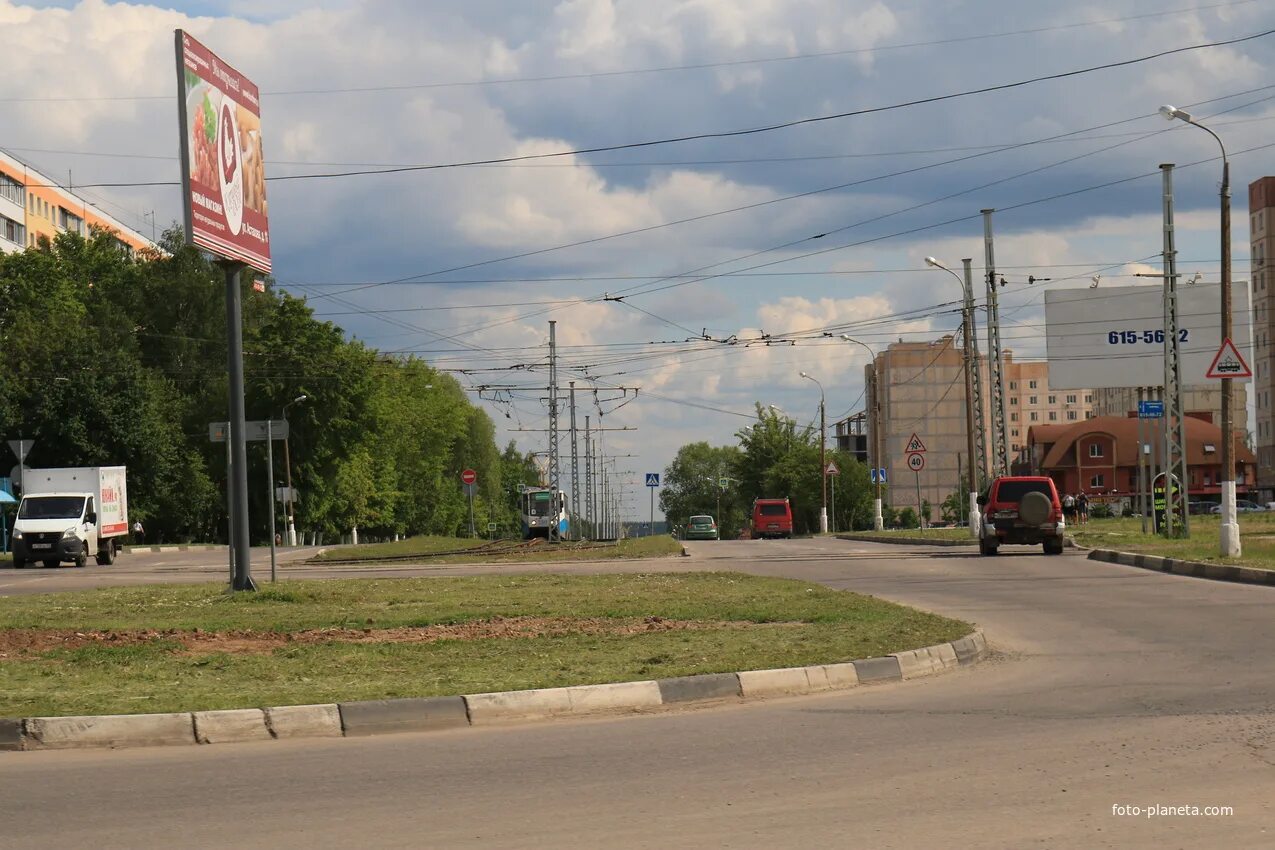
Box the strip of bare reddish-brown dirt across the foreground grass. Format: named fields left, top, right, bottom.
left=0, top=617, right=755, bottom=660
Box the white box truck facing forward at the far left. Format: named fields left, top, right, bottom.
left=13, top=466, right=129, bottom=570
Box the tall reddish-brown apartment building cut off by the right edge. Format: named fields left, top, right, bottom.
left=1249, top=177, right=1275, bottom=502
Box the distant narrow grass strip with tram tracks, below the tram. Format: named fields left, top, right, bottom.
left=314, top=534, right=682, bottom=563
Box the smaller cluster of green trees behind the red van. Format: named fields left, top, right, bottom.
left=659, top=404, right=887, bottom=538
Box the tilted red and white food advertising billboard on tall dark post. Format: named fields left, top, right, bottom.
left=176, top=29, right=270, bottom=273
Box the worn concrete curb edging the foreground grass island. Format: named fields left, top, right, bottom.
left=0, top=629, right=989, bottom=751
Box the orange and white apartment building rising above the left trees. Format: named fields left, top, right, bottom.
left=0, top=152, right=153, bottom=252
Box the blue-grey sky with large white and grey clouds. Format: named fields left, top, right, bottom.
left=0, top=0, right=1275, bottom=516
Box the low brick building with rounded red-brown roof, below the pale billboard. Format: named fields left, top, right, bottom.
left=1019, top=415, right=1257, bottom=501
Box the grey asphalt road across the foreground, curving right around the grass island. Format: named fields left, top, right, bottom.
left=0, top=540, right=1275, bottom=850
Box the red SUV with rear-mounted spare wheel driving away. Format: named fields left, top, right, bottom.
left=978, top=475, right=1067, bottom=554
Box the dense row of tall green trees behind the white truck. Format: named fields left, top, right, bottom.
left=0, top=231, right=539, bottom=540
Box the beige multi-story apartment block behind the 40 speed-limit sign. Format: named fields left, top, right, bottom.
left=864, top=335, right=1093, bottom=520
